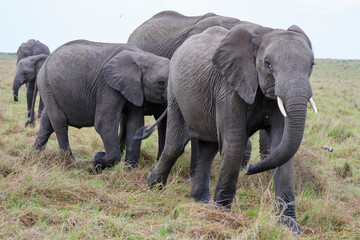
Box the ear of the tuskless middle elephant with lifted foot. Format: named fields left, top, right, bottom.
left=103, top=50, right=144, bottom=107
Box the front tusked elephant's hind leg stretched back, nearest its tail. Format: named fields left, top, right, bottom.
left=147, top=103, right=189, bottom=187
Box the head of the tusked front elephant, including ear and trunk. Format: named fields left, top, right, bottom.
left=212, top=22, right=315, bottom=175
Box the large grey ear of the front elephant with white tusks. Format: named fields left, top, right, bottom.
left=212, top=22, right=267, bottom=104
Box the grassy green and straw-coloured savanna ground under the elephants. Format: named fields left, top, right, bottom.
left=0, top=54, right=360, bottom=239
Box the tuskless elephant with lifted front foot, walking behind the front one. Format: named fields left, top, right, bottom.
left=34, top=40, right=169, bottom=171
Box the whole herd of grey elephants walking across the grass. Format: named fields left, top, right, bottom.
left=13, top=11, right=317, bottom=233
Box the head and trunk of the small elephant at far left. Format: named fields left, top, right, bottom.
left=13, top=54, right=48, bottom=101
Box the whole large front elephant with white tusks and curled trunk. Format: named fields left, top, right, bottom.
left=148, top=22, right=314, bottom=232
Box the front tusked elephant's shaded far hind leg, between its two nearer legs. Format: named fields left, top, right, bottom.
left=191, top=140, right=218, bottom=203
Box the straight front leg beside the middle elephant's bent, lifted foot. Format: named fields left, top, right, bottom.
left=125, top=107, right=144, bottom=168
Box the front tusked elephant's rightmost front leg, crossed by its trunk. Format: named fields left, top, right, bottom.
left=271, top=130, right=301, bottom=233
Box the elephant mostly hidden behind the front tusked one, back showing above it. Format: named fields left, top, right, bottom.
left=128, top=11, right=251, bottom=177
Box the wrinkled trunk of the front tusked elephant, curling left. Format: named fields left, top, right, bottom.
left=246, top=88, right=311, bottom=175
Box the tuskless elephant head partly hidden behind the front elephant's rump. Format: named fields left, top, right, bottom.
left=103, top=50, right=170, bottom=107
